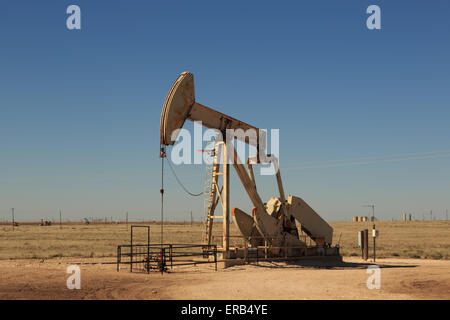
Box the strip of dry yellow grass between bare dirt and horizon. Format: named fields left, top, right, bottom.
left=0, top=221, right=450, bottom=260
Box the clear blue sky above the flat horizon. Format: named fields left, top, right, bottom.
left=0, top=0, right=450, bottom=221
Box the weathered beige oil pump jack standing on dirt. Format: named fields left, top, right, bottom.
left=160, top=72, right=339, bottom=258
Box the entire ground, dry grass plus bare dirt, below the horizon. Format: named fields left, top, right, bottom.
left=0, top=221, right=450, bottom=300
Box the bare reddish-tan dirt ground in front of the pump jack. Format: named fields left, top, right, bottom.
left=0, top=258, right=450, bottom=300
